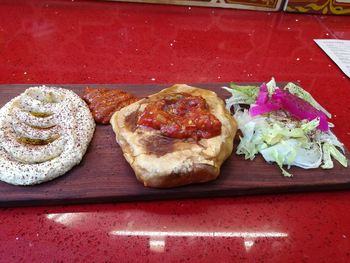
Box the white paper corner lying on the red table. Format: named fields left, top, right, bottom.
left=314, top=39, right=350, bottom=78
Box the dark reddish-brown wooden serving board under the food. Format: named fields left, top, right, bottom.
left=0, top=84, right=350, bottom=207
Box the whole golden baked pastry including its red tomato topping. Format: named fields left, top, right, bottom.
left=111, top=84, right=237, bottom=188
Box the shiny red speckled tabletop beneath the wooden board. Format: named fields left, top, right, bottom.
left=0, top=0, right=350, bottom=262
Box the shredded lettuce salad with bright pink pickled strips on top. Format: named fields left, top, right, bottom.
left=223, top=78, right=348, bottom=177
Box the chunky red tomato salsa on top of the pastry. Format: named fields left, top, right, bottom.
left=137, top=93, right=221, bottom=141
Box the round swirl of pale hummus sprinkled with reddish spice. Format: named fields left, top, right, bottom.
left=0, top=86, right=95, bottom=185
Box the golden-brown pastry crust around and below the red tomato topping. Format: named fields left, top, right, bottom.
left=111, top=84, right=237, bottom=188
